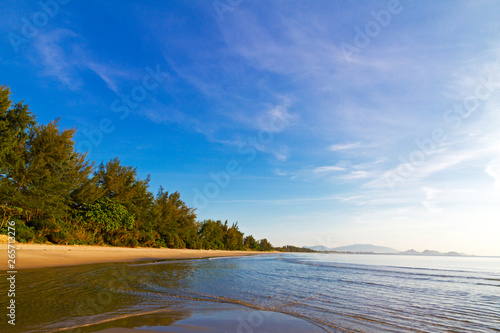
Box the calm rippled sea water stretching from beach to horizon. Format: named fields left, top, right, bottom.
left=0, top=254, right=500, bottom=332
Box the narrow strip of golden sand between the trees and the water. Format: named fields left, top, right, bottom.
left=0, top=243, right=258, bottom=271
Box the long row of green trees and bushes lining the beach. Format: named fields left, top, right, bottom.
left=0, top=86, right=273, bottom=251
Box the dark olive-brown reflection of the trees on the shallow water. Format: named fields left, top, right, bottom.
left=0, top=260, right=205, bottom=332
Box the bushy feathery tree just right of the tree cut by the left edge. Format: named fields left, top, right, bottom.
left=11, top=120, right=92, bottom=222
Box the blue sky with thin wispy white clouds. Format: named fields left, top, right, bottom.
left=0, top=0, right=500, bottom=256
